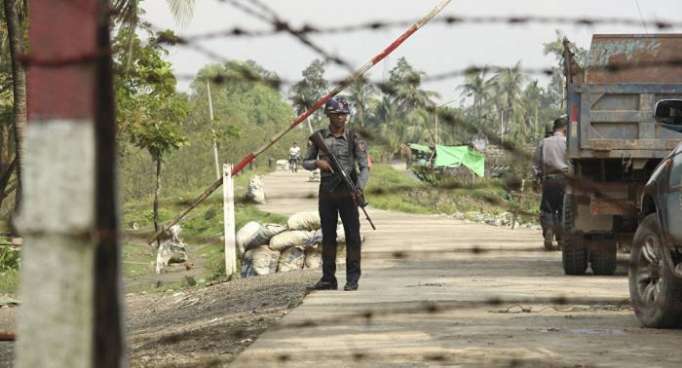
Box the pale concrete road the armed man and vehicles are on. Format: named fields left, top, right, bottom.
left=233, top=173, right=682, bottom=367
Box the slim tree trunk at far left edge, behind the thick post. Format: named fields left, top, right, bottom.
left=4, top=0, right=26, bottom=214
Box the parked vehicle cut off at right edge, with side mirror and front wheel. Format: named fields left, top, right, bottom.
left=629, top=100, right=682, bottom=328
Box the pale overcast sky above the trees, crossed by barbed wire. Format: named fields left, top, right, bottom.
left=143, top=0, right=682, bottom=101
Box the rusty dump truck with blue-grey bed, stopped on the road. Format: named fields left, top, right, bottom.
left=561, top=34, right=682, bottom=275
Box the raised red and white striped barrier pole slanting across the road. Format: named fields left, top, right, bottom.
left=148, top=0, right=452, bottom=244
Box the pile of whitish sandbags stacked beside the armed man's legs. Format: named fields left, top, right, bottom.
left=237, top=211, right=354, bottom=277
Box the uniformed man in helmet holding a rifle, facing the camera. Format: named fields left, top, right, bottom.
left=303, top=97, right=369, bottom=291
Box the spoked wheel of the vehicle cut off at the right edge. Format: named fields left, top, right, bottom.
left=629, top=213, right=682, bottom=328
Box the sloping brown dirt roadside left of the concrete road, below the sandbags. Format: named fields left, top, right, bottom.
left=0, top=271, right=318, bottom=368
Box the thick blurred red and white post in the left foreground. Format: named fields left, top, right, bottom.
left=15, top=0, right=126, bottom=368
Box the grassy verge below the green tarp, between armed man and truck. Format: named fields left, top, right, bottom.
left=366, top=164, right=539, bottom=222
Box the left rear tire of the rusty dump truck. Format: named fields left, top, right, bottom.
left=561, top=194, right=587, bottom=275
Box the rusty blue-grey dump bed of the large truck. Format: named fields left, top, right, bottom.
left=567, top=34, right=682, bottom=159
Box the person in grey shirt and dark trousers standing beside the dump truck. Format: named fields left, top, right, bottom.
left=533, top=117, right=568, bottom=249
